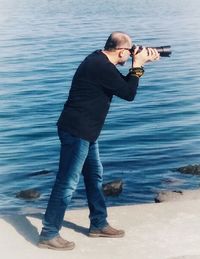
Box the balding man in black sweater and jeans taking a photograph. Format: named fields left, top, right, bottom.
left=38, top=32, right=159, bottom=250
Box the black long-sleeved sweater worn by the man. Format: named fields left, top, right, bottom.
left=57, top=50, right=139, bottom=142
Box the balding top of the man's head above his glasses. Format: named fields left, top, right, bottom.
left=104, top=31, right=132, bottom=51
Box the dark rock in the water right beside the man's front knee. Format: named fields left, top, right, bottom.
left=103, top=180, right=123, bottom=196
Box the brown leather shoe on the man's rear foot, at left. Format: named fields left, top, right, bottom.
left=38, top=236, right=75, bottom=251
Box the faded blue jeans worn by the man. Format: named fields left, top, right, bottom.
left=40, top=130, right=108, bottom=240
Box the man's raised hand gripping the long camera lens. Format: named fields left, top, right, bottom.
left=133, top=47, right=160, bottom=67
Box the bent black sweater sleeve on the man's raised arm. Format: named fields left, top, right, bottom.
left=99, top=62, right=139, bottom=101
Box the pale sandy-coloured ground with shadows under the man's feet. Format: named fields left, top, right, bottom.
left=0, top=200, right=200, bottom=259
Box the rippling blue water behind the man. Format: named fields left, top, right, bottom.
left=0, top=0, right=200, bottom=214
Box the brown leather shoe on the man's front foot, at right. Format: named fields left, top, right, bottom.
left=89, top=225, right=125, bottom=238
